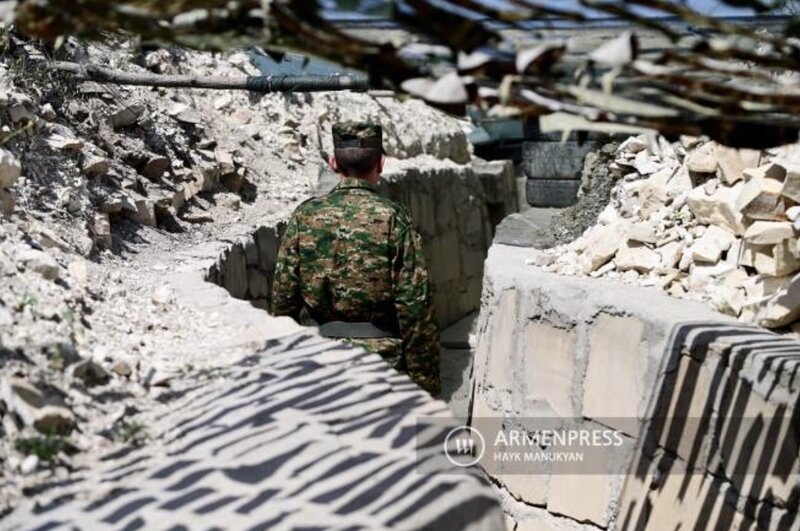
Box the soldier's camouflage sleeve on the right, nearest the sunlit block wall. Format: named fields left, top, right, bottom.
left=394, top=216, right=441, bottom=395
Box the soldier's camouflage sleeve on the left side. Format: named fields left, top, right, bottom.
left=272, top=216, right=302, bottom=319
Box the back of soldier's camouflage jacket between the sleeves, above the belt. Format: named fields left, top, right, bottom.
left=294, top=178, right=410, bottom=330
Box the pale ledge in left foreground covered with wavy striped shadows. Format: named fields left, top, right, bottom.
left=9, top=334, right=503, bottom=531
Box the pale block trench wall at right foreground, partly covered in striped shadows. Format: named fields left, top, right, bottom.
left=471, top=245, right=800, bottom=531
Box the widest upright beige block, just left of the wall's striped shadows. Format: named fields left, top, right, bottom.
left=582, top=313, right=647, bottom=435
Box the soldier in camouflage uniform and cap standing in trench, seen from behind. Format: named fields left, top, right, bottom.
left=272, top=122, right=440, bottom=395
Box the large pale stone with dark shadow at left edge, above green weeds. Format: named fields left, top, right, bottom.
left=0, top=378, right=75, bottom=433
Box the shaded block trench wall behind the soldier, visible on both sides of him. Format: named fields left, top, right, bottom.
left=206, top=156, right=518, bottom=419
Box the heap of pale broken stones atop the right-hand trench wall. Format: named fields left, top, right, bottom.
left=529, top=135, right=800, bottom=329
